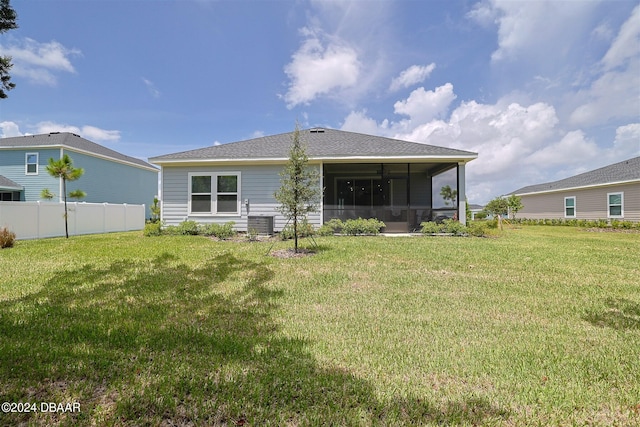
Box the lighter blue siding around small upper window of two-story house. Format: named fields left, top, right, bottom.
left=0, top=147, right=60, bottom=202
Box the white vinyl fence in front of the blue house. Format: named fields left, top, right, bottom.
left=0, top=202, right=146, bottom=239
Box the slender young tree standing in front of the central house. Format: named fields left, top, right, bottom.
left=274, top=123, right=322, bottom=252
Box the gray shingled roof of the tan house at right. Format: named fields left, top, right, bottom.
left=511, top=157, right=640, bottom=194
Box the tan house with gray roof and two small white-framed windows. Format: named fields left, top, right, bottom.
left=513, top=157, right=640, bottom=221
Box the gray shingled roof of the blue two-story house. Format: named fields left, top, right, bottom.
left=0, top=132, right=157, bottom=169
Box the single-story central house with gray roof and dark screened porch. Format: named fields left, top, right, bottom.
left=149, top=128, right=477, bottom=232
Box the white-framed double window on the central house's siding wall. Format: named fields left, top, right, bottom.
left=189, top=172, right=240, bottom=215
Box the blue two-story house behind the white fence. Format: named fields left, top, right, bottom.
left=0, top=132, right=158, bottom=217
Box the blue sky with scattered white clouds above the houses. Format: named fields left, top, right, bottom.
left=0, top=0, right=640, bottom=203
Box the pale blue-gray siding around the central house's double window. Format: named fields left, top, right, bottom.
left=162, top=165, right=320, bottom=231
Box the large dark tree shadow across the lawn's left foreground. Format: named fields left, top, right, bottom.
left=0, top=252, right=509, bottom=425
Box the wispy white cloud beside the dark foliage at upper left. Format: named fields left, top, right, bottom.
left=0, top=38, right=80, bottom=86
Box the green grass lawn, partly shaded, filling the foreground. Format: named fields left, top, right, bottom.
left=0, top=226, right=640, bottom=426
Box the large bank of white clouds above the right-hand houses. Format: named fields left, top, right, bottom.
left=342, top=84, right=640, bottom=203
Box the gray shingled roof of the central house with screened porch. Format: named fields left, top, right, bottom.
left=149, top=128, right=477, bottom=163
